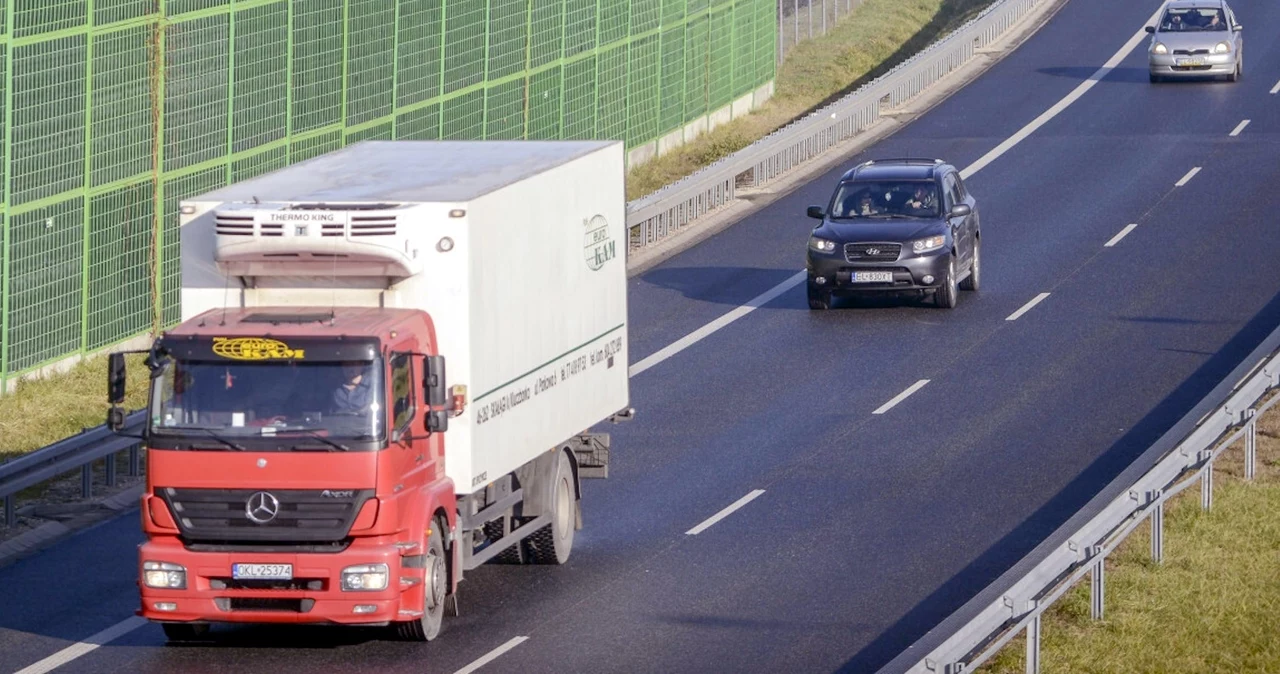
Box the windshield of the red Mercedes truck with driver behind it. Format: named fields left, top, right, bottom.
left=151, top=359, right=385, bottom=450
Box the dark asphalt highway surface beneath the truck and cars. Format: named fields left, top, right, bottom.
left=0, top=0, right=1280, bottom=674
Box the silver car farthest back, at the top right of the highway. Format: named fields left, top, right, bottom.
left=1147, top=0, right=1244, bottom=82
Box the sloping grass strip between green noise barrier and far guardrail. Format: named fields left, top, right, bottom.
left=627, top=0, right=993, bottom=200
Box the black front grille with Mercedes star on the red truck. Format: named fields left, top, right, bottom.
left=160, top=487, right=374, bottom=544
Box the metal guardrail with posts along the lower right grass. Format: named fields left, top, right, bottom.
left=881, top=323, right=1280, bottom=674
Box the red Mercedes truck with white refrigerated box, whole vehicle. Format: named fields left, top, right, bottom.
left=108, top=141, right=634, bottom=641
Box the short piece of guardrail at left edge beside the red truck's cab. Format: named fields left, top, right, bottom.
left=0, top=411, right=146, bottom=527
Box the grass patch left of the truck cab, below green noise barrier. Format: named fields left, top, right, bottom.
left=0, top=354, right=148, bottom=462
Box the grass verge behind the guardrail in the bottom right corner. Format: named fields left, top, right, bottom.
left=978, top=393, right=1280, bottom=674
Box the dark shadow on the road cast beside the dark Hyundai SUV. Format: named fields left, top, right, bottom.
left=641, top=267, right=809, bottom=311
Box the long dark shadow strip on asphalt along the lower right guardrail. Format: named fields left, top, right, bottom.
left=840, top=285, right=1280, bottom=671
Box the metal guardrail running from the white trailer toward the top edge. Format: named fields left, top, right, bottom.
left=627, top=0, right=1051, bottom=249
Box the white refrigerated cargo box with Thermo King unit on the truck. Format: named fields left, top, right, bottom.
left=180, top=141, right=630, bottom=495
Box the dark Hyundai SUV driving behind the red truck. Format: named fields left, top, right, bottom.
left=806, top=159, right=980, bottom=310
